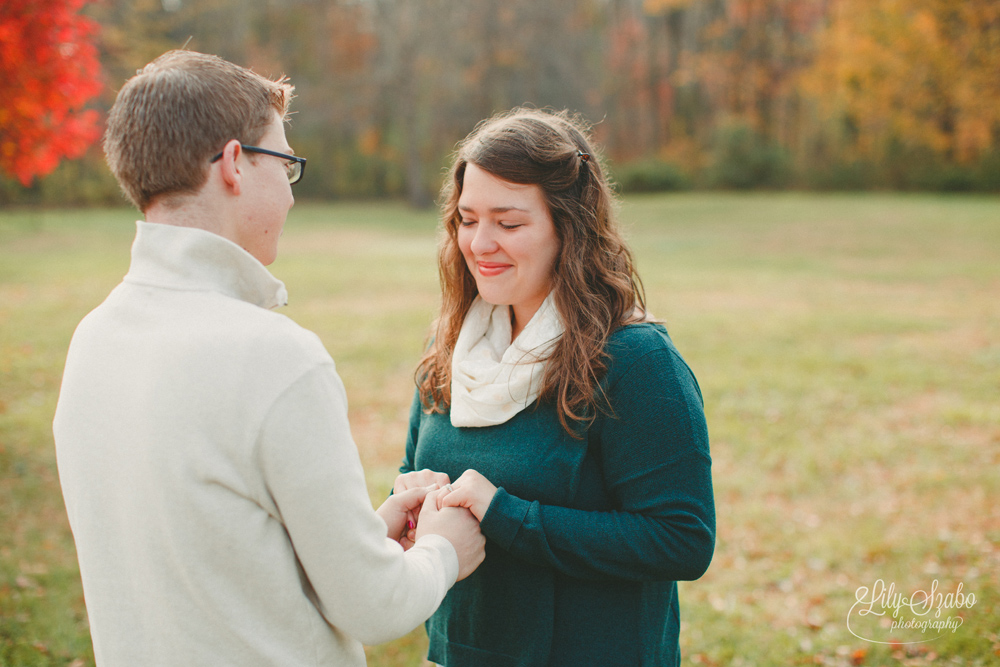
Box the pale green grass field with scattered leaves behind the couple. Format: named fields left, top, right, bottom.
left=0, top=194, right=1000, bottom=667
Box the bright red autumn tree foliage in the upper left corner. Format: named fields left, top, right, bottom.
left=0, top=0, right=101, bottom=186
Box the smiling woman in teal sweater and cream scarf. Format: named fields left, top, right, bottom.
left=394, top=109, right=715, bottom=667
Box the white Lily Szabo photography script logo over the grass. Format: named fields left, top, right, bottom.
left=847, top=579, right=976, bottom=645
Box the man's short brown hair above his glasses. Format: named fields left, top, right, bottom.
left=104, top=51, right=294, bottom=211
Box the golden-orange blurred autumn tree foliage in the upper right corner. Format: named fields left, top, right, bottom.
left=807, top=0, right=1000, bottom=171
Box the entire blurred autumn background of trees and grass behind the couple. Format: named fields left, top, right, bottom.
left=0, top=0, right=1000, bottom=667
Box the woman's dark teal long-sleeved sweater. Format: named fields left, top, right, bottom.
left=400, top=324, right=715, bottom=667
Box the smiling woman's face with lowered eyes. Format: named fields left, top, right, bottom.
left=458, top=162, right=559, bottom=335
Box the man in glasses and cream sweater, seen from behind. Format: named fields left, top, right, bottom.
left=54, top=51, right=484, bottom=667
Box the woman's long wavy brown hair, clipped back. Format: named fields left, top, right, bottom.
left=416, top=108, right=646, bottom=437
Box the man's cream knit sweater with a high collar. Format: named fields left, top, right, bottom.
left=54, top=222, right=458, bottom=667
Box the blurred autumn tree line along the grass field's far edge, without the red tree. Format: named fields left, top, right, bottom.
left=0, top=0, right=1000, bottom=205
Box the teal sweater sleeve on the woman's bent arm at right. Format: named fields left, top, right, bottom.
left=482, top=349, right=715, bottom=581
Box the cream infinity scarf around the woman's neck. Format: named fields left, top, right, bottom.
left=451, top=292, right=563, bottom=426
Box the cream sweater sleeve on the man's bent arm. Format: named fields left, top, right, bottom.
left=258, top=362, right=458, bottom=644
